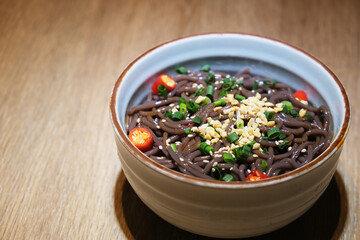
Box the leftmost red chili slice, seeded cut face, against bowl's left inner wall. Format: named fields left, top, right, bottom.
left=129, top=127, right=154, bottom=152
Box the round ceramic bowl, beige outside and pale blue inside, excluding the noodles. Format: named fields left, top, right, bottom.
left=110, top=33, right=350, bottom=238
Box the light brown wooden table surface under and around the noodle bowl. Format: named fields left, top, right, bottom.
left=0, top=0, right=360, bottom=239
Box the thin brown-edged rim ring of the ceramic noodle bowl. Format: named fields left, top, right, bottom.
left=110, top=32, right=350, bottom=189
